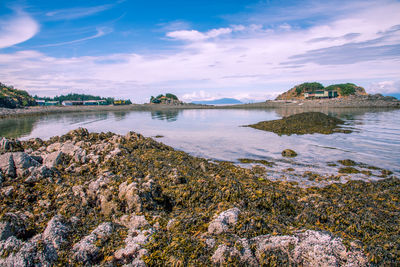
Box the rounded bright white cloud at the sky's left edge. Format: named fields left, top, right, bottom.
left=0, top=11, right=39, bottom=49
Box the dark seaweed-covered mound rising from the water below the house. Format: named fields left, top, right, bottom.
left=248, top=112, right=351, bottom=135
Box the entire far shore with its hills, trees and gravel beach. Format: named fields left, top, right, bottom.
left=0, top=82, right=400, bottom=118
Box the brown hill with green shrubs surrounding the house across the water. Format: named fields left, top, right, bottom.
left=276, top=82, right=368, bottom=100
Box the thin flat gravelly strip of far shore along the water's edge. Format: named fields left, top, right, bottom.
left=0, top=97, right=400, bottom=119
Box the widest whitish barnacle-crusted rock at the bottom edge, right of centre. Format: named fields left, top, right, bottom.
left=251, top=230, right=367, bottom=266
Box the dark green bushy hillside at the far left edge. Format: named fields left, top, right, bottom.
left=0, top=83, right=36, bottom=108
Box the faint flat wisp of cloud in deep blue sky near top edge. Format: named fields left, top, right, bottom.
left=46, top=5, right=114, bottom=20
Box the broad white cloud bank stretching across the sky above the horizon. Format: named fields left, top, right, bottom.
left=0, top=2, right=400, bottom=102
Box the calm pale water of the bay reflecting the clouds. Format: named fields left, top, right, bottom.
left=0, top=109, right=400, bottom=181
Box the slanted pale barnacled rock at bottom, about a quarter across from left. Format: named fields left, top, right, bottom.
left=72, top=222, right=113, bottom=265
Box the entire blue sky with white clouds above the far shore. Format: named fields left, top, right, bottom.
left=0, top=0, right=400, bottom=103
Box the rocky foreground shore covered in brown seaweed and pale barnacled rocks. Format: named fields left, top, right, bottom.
left=0, top=128, right=400, bottom=266
